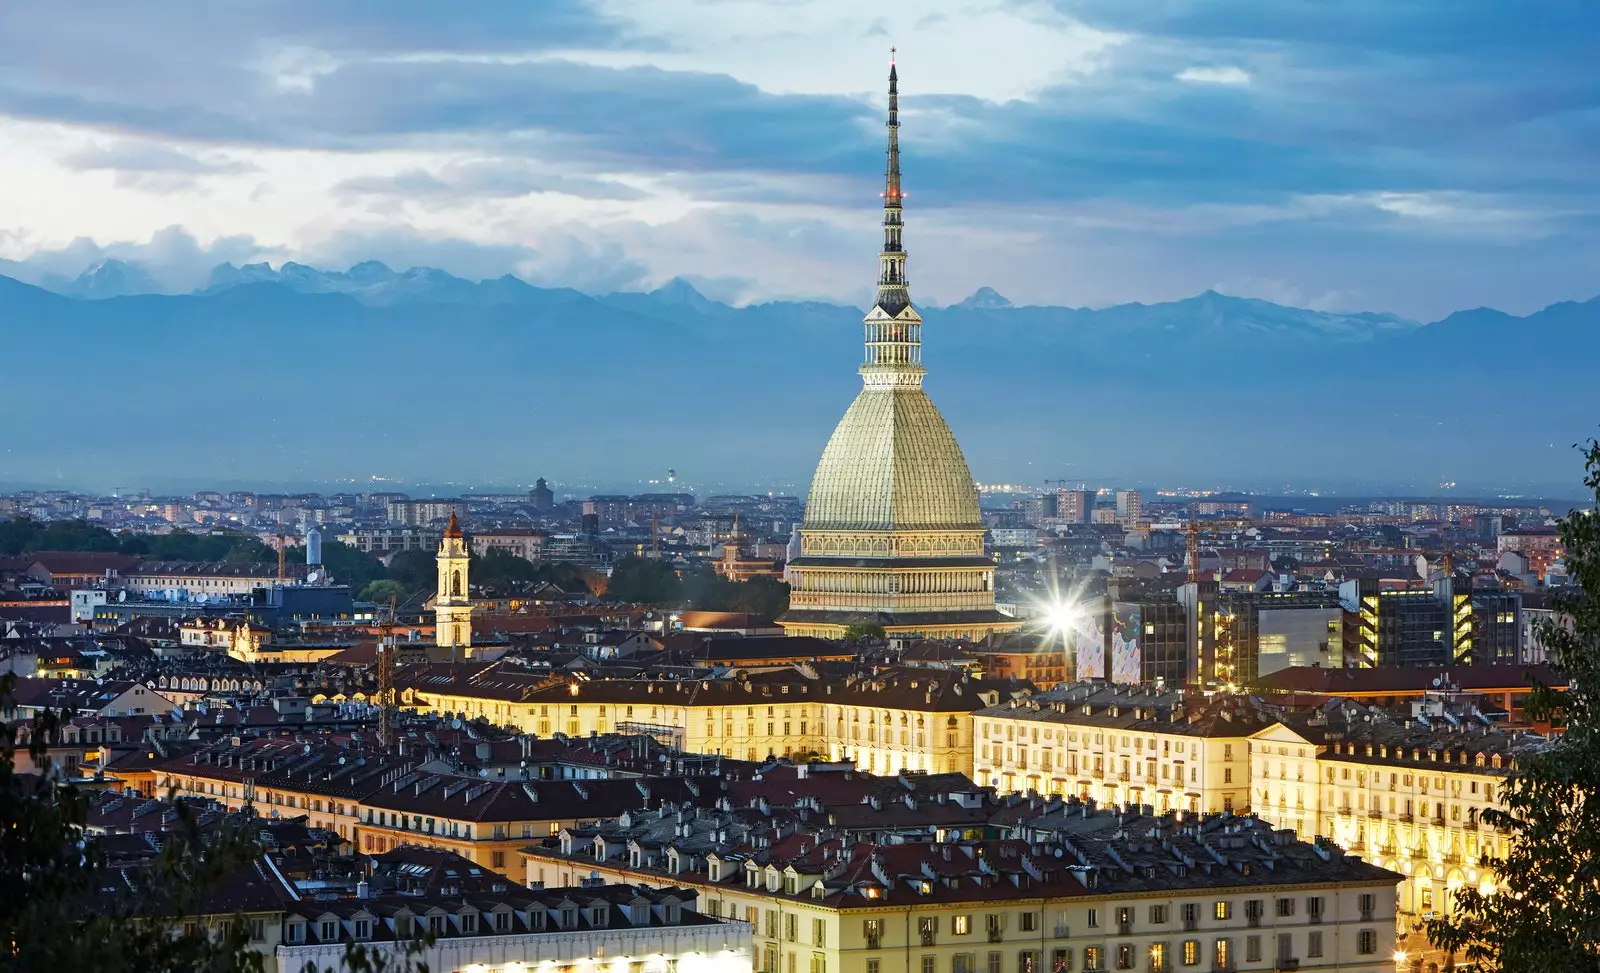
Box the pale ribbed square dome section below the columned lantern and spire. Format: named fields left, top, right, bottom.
left=805, top=386, right=982, bottom=530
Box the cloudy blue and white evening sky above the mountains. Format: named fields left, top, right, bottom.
left=0, top=0, right=1600, bottom=318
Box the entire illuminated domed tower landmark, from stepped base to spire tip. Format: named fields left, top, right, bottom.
left=778, top=58, right=1019, bottom=639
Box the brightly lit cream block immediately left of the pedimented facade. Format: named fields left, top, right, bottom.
left=973, top=680, right=1277, bottom=813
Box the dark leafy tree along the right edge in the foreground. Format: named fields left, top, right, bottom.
left=1427, top=442, right=1600, bottom=973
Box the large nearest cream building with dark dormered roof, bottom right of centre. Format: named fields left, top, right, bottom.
left=523, top=799, right=1400, bottom=973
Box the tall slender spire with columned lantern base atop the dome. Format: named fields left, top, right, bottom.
left=861, top=48, right=923, bottom=384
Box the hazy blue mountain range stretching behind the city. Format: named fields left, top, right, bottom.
left=0, top=259, right=1600, bottom=490
